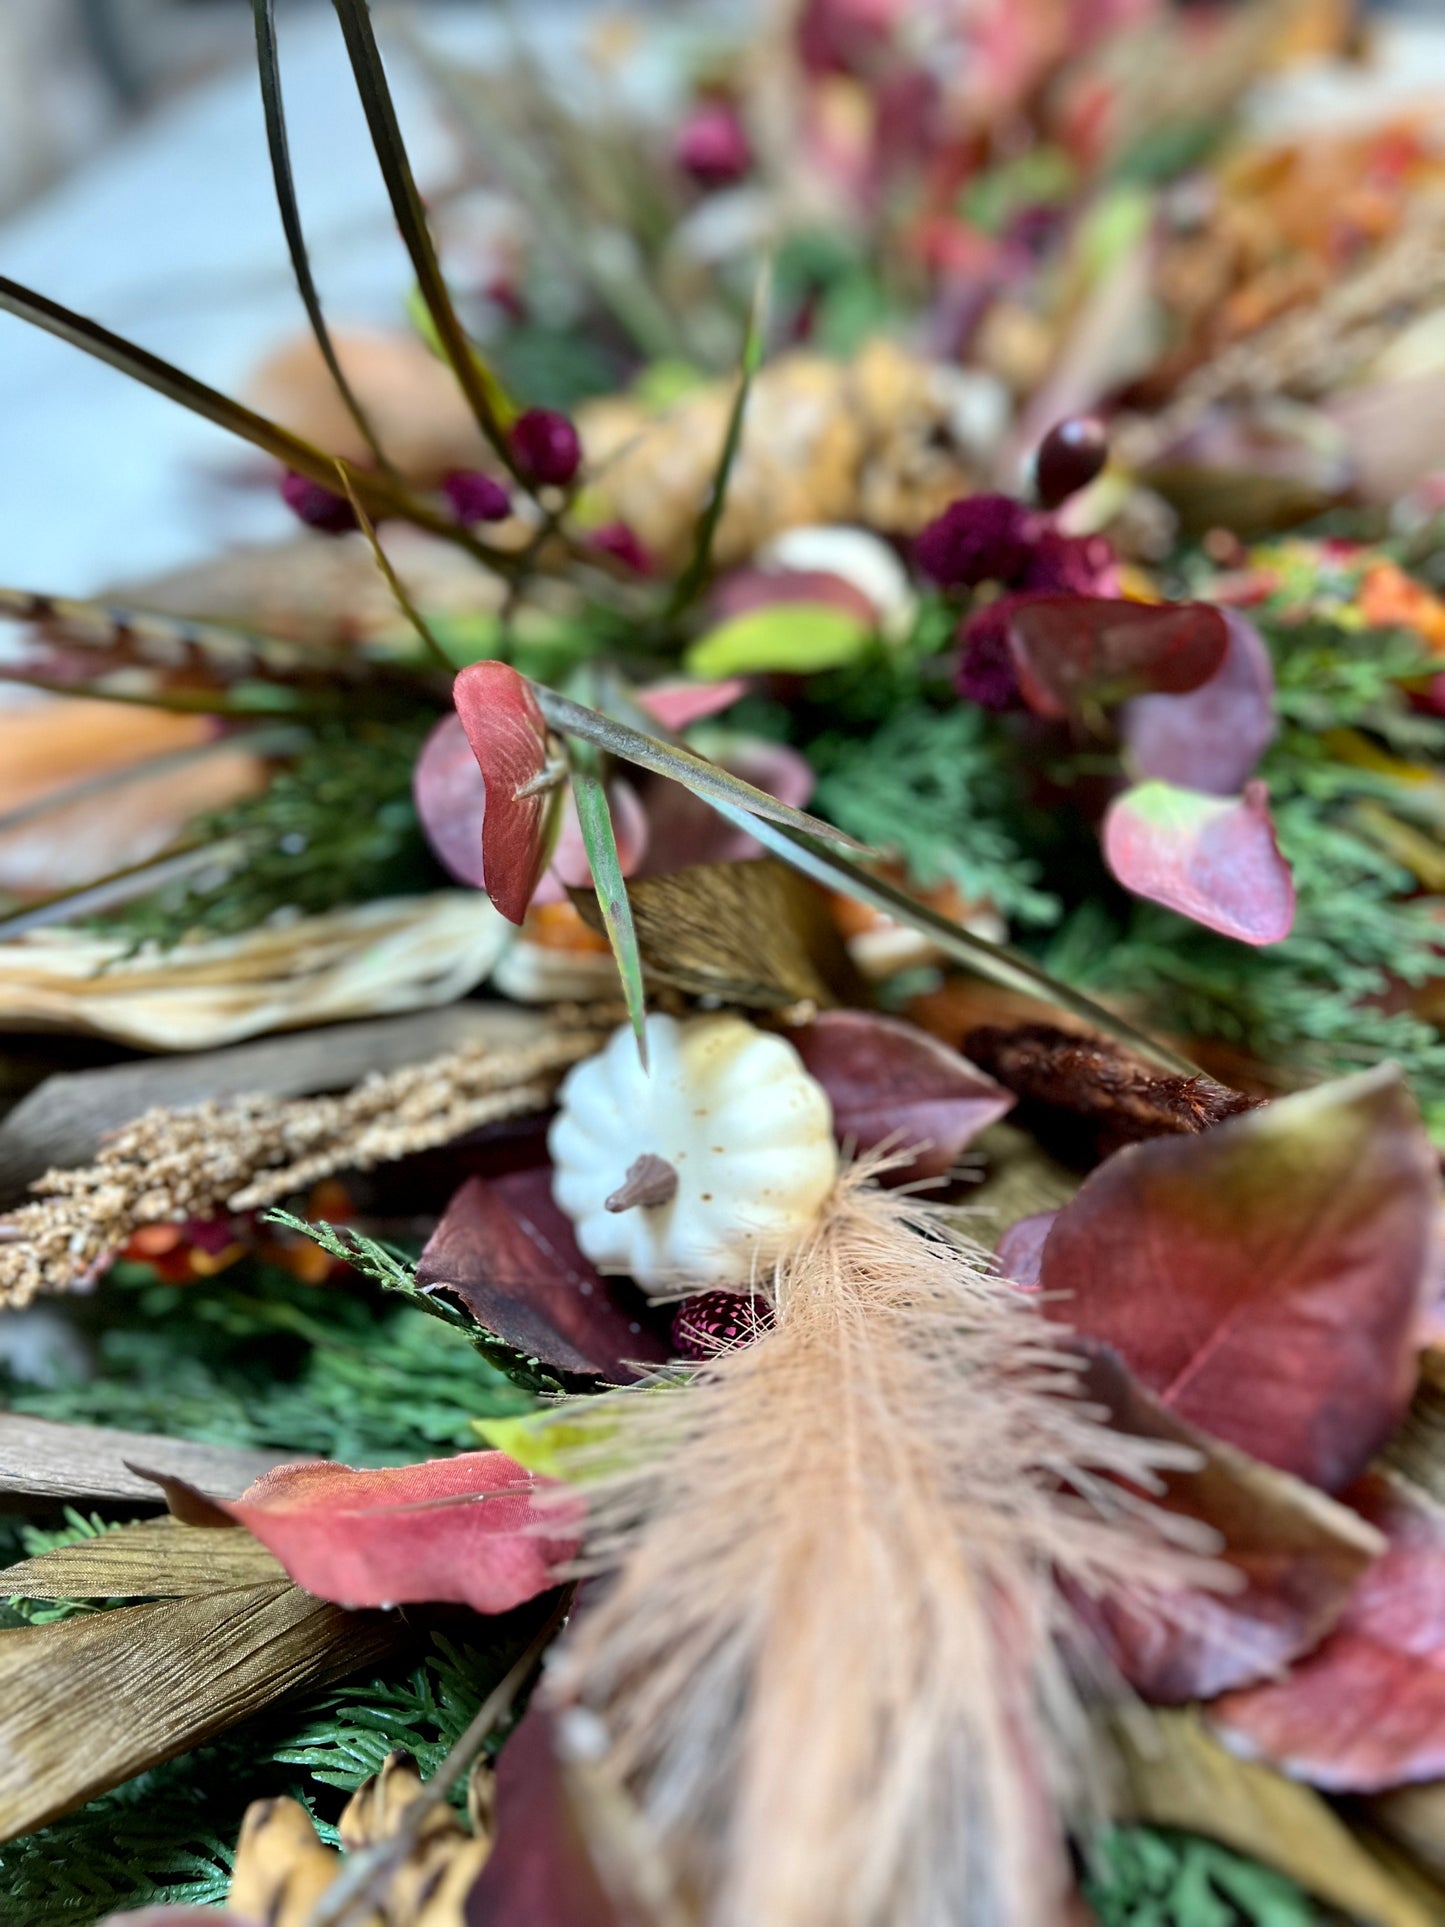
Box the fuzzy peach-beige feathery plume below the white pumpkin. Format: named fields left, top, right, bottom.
left=553, top=1174, right=1218, bottom=1927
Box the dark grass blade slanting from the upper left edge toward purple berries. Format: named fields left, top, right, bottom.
left=0, top=276, right=464, bottom=543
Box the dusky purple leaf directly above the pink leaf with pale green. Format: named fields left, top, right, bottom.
left=1119, top=609, right=1275, bottom=796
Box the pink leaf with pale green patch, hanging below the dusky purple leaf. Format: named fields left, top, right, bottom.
left=1104, top=782, right=1295, bottom=944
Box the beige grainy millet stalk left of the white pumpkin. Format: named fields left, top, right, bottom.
left=0, top=1025, right=607, bottom=1307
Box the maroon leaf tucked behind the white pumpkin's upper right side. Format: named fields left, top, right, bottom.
left=788, top=1010, right=1013, bottom=1183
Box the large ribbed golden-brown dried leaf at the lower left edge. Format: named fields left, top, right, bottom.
left=0, top=1582, right=407, bottom=1840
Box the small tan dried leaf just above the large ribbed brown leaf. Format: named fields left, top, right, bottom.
left=0, top=1518, right=285, bottom=1599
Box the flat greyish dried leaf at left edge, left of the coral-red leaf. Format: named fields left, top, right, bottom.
left=0, top=1412, right=302, bottom=1505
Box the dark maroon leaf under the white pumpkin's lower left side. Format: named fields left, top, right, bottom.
left=416, top=1170, right=669, bottom=1384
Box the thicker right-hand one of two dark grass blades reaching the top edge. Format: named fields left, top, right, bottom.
left=333, top=0, right=524, bottom=480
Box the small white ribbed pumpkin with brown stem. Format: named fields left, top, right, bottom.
left=547, top=1016, right=838, bottom=1289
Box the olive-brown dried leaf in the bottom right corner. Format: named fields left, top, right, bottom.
left=1117, top=1713, right=1439, bottom=1927
